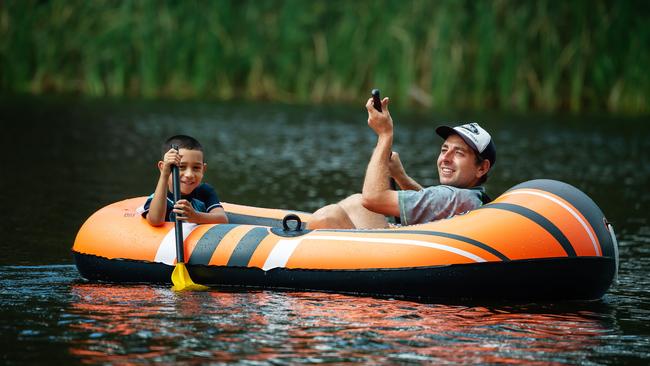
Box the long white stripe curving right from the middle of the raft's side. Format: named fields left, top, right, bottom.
left=262, top=235, right=486, bottom=271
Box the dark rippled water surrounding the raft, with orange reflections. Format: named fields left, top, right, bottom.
left=0, top=98, right=650, bottom=364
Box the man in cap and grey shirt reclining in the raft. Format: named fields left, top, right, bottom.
left=308, top=98, right=496, bottom=229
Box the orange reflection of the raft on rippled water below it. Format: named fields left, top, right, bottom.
left=64, top=284, right=614, bottom=364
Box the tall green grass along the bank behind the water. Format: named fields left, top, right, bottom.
left=0, top=0, right=650, bottom=113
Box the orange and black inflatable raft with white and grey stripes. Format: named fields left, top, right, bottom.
left=72, top=180, right=618, bottom=300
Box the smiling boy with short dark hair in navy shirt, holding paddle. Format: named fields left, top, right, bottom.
left=142, top=135, right=228, bottom=226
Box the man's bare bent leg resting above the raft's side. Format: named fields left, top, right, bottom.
left=307, top=193, right=388, bottom=230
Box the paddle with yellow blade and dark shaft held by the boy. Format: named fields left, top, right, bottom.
left=172, top=145, right=208, bottom=291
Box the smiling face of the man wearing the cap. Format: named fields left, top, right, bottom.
left=437, top=134, right=487, bottom=188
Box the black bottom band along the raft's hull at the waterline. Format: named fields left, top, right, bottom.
left=73, top=252, right=615, bottom=301
